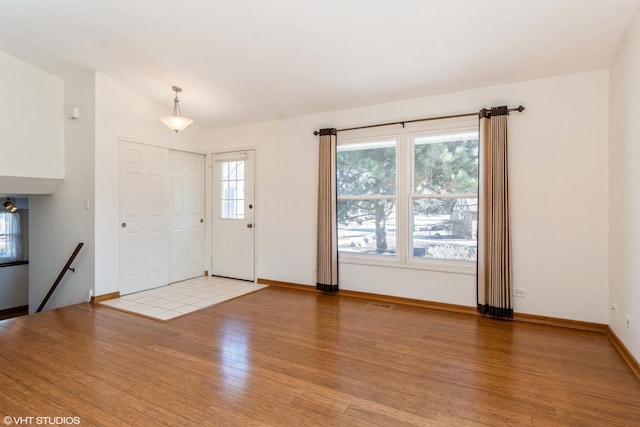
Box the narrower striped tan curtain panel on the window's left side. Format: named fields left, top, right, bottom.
left=316, top=129, right=338, bottom=292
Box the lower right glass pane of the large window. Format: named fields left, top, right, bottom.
left=412, top=198, right=478, bottom=261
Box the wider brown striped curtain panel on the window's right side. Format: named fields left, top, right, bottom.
left=477, top=106, right=513, bottom=318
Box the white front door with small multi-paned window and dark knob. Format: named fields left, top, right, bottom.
left=211, top=150, right=255, bottom=281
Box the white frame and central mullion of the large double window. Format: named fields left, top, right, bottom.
left=337, top=117, right=479, bottom=275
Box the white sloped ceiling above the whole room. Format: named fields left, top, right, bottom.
left=0, top=0, right=639, bottom=126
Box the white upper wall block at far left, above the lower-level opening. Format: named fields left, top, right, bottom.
left=0, top=51, right=64, bottom=181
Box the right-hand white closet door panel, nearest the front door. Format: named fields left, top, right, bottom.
left=169, top=150, right=205, bottom=282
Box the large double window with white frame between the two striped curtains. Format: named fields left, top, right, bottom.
left=337, top=122, right=478, bottom=264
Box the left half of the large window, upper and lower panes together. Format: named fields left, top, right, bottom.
left=336, top=139, right=397, bottom=256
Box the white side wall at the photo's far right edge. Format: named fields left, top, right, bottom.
left=609, top=10, right=640, bottom=360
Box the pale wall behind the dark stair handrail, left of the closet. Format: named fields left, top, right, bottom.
left=29, top=73, right=95, bottom=313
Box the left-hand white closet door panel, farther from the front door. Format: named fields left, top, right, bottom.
left=119, top=141, right=169, bottom=295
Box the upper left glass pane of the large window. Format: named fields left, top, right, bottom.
left=337, top=140, right=396, bottom=196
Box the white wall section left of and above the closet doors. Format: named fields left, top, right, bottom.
left=95, top=72, right=206, bottom=295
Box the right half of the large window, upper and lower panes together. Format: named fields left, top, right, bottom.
left=410, top=132, right=478, bottom=261
